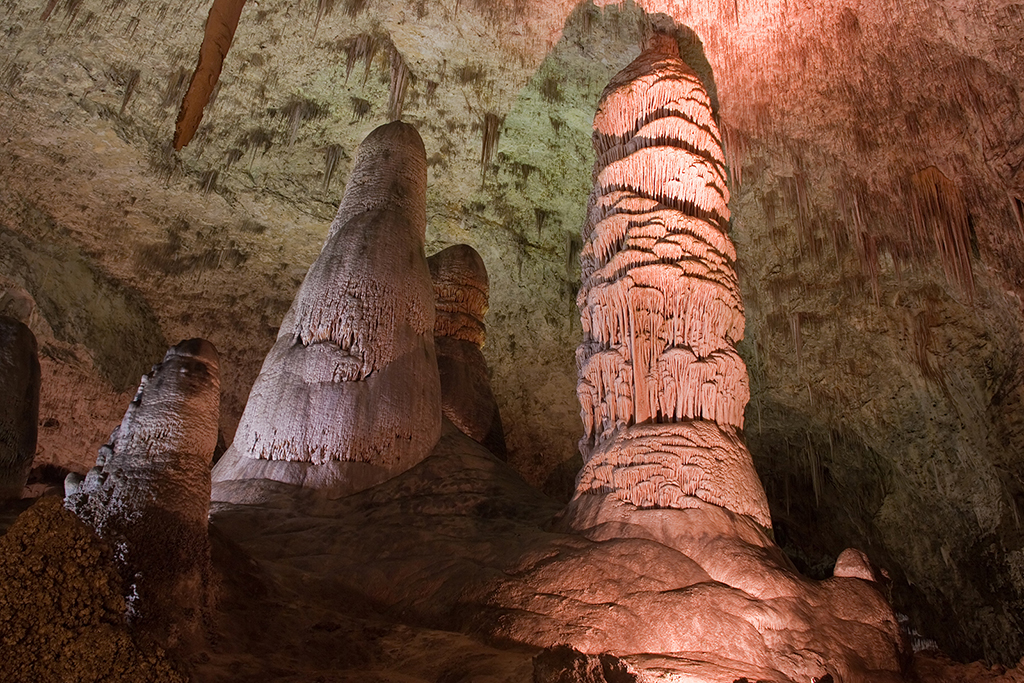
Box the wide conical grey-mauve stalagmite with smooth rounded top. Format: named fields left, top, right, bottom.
left=213, top=122, right=440, bottom=502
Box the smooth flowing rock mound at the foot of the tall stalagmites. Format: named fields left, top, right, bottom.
left=205, top=425, right=902, bottom=683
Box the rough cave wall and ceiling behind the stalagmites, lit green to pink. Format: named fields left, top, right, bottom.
left=0, top=0, right=1024, bottom=661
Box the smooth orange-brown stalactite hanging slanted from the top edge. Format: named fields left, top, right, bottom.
left=173, top=0, right=246, bottom=150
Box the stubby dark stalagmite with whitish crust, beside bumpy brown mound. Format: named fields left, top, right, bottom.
left=65, top=339, right=220, bottom=647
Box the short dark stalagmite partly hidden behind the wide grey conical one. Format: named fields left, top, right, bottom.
left=427, top=245, right=506, bottom=460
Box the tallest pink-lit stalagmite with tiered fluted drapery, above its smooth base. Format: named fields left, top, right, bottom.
left=577, top=34, right=771, bottom=527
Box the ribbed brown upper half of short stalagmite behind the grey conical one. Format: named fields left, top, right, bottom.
left=427, top=245, right=489, bottom=346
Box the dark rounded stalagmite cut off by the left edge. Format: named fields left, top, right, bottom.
left=0, top=316, right=40, bottom=499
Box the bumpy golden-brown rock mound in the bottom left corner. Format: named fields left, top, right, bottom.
left=0, top=498, right=187, bottom=683
